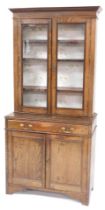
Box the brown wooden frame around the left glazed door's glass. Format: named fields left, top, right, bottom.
left=14, top=18, right=51, bottom=114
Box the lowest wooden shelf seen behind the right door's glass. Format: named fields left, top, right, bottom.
left=57, top=87, right=83, bottom=93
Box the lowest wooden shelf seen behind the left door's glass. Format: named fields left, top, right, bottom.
left=23, top=86, right=47, bottom=93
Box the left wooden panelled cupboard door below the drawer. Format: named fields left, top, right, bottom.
left=7, top=132, right=45, bottom=188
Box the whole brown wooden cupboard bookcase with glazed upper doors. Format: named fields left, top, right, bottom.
left=6, top=7, right=99, bottom=204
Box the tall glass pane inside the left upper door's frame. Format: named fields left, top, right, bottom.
left=22, top=24, right=48, bottom=107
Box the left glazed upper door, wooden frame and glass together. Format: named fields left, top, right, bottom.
left=15, top=19, right=51, bottom=113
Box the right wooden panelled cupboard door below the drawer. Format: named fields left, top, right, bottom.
left=46, top=135, right=88, bottom=192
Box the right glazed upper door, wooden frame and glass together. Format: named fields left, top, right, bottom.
left=52, top=17, right=90, bottom=115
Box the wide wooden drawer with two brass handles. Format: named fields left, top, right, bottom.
left=7, top=120, right=89, bottom=135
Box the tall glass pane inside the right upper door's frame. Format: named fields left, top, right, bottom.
left=57, top=24, right=85, bottom=109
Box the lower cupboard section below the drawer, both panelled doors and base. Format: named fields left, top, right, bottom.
left=6, top=131, right=91, bottom=204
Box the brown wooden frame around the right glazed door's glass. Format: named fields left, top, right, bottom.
left=52, top=16, right=91, bottom=116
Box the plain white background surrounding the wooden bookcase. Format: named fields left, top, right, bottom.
left=0, top=0, right=105, bottom=210
